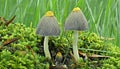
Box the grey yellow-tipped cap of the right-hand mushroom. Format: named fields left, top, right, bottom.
left=65, top=7, right=88, bottom=31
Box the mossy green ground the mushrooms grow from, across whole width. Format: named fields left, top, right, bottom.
left=0, top=23, right=120, bottom=69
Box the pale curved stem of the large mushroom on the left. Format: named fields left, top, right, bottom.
left=44, top=36, right=51, bottom=59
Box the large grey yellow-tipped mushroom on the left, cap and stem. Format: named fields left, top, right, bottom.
left=36, top=11, right=60, bottom=59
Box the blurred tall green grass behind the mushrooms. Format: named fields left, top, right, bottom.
left=0, top=0, right=120, bottom=46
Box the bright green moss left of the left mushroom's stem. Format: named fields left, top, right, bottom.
left=0, top=23, right=46, bottom=69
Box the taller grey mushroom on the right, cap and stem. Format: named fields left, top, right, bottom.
left=65, top=7, right=88, bottom=60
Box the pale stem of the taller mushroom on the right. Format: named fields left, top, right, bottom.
left=73, top=31, right=79, bottom=60
